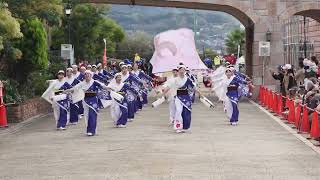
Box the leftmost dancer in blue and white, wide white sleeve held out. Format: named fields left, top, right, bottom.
left=41, top=70, right=72, bottom=130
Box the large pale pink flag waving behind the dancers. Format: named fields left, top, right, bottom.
left=150, top=28, right=207, bottom=73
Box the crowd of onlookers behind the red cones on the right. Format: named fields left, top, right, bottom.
left=271, top=56, right=320, bottom=141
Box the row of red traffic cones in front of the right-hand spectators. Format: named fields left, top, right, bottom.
left=259, top=86, right=320, bottom=139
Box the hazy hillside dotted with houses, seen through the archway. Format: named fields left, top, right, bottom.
left=108, top=5, right=240, bottom=49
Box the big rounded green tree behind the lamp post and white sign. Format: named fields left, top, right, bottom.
left=52, top=4, right=124, bottom=62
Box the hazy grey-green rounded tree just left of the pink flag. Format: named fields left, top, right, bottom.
left=116, top=31, right=154, bottom=60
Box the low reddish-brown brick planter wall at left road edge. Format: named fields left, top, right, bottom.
left=7, top=98, right=52, bottom=123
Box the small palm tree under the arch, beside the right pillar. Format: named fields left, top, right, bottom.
left=226, top=29, right=246, bottom=56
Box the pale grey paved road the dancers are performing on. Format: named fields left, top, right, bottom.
left=0, top=102, right=320, bottom=180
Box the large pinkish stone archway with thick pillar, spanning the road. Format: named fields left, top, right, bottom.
left=80, top=0, right=320, bottom=88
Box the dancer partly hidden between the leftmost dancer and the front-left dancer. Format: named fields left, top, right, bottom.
left=65, top=68, right=80, bottom=125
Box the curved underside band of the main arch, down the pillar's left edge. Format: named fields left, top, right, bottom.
left=82, top=0, right=259, bottom=76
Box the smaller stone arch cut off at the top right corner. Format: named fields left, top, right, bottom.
left=278, top=0, right=320, bottom=22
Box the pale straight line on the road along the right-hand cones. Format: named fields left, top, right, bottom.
left=249, top=100, right=320, bottom=154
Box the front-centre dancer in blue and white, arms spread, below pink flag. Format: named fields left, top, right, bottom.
left=163, top=64, right=201, bottom=133
